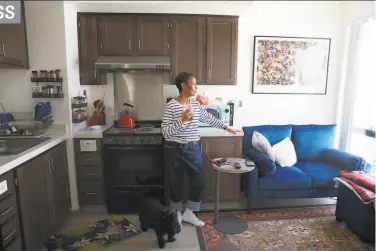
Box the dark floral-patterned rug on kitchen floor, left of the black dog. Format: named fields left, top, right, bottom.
left=45, top=216, right=141, bottom=251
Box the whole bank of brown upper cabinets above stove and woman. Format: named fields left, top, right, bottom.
left=79, top=14, right=238, bottom=85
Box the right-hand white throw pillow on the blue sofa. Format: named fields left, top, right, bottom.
left=272, top=138, right=297, bottom=167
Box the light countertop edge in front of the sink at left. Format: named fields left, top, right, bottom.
left=0, top=128, right=67, bottom=175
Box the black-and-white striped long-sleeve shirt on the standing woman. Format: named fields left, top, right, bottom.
left=162, top=99, right=226, bottom=143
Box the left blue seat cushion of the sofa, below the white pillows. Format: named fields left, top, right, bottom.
left=259, top=166, right=311, bottom=190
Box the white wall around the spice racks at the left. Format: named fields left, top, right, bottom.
left=0, top=1, right=69, bottom=124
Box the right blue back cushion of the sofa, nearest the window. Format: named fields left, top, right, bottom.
left=291, top=125, right=336, bottom=161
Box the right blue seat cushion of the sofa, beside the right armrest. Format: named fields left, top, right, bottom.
left=295, top=161, right=339, bottom=188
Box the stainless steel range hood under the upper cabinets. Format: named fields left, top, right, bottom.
left=95, top=56, right=171, bottom=72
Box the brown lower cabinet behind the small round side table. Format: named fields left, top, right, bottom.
left=201, top=137, right=242, bottom=202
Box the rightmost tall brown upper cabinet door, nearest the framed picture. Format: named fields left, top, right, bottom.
left=206, top=17, right=238, bottom=85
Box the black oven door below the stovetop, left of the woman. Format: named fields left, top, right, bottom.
left=103, top=145, right=163, bottom=188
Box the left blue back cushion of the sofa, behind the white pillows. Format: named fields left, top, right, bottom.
left=243, top=125, right=291, bottom=153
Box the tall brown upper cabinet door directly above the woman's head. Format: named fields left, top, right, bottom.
left=171, top=16, right=206, bottom=83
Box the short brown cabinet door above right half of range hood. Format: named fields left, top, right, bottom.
left=136, top=16, right=170, bottom=55
